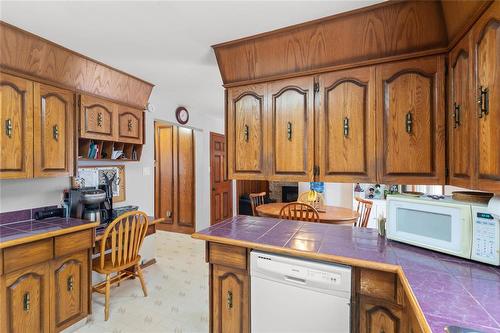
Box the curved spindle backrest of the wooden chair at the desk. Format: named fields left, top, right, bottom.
left=100, top=211, right=148, bottom=269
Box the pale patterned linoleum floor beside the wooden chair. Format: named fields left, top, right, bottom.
left=76, top=231, right=208, bottom=333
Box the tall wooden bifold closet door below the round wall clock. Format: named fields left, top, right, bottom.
left=155, top=122, right=196, bottom=234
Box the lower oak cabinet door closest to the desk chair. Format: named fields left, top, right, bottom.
left=52, top=251, right=89, bottom=331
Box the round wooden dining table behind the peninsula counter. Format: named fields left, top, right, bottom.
left=255, top=202, right=359, bottom=224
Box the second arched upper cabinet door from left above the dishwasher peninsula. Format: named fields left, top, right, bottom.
left=267, top=76, right=314, bottom=181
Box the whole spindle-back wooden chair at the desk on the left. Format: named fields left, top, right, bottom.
left=92, top=211, right=148, bottom=320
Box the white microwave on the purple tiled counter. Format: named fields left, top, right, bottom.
left=386, top=195, right=500, bottom=266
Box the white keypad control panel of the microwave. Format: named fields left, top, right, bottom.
left=472, top=210, right=500, bottom=265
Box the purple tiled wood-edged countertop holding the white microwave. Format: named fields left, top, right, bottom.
left=193, top=216, right=500, bottom=333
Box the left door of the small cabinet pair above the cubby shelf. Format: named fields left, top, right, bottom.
left=80, top=95, right=118, bottom=141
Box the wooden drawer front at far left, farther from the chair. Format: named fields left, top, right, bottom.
left=3, top=238, right=53, bottom=273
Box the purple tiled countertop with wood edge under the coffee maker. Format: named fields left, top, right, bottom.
left=0, top=217, right=99, bottom=249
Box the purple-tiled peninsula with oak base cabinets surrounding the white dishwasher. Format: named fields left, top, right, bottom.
left=192, top=216, right=500, bottom=333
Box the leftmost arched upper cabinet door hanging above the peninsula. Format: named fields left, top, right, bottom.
left=227, top=84, right=268, bottom=179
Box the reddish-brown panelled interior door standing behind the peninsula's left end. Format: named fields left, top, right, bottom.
left=210, top=133, right=233, bottom=225
